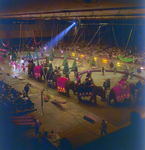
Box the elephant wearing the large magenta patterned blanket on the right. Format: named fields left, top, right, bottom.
left=108, top=83, right=136, bottom=105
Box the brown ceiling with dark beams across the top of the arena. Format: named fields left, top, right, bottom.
left=0, top=0, right=145, bottom=20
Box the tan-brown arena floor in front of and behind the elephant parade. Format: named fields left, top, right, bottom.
left=0, top=51, right=145, bottom=148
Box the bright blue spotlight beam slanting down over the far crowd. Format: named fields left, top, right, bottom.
left=47, top=22, right=75, bottom=49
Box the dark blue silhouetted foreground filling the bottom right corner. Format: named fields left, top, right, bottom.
left=75, top=112, right=145, bottom=150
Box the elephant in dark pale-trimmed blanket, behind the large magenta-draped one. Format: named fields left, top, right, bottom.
left=77, top=84, right=106, bottom=104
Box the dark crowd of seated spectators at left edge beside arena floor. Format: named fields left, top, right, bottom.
left=0, top=80, right=34, bottom=113
